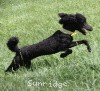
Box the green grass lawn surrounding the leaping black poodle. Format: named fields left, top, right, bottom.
left=0, top=0, right=100, bottom=91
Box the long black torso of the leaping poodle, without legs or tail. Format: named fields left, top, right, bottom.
left=10, top=30, right=73, bottom=60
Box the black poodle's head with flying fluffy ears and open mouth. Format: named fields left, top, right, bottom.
left=58, top=13, right=93, bottom=35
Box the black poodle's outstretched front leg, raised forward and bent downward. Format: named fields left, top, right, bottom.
left=69, top=40, right=91, bottom=52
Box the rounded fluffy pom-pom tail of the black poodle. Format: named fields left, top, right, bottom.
left=7, top=37, right=19, bottom=52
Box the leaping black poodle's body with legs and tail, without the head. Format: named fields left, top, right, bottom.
left=6, top=30, right=91, bottom=72
